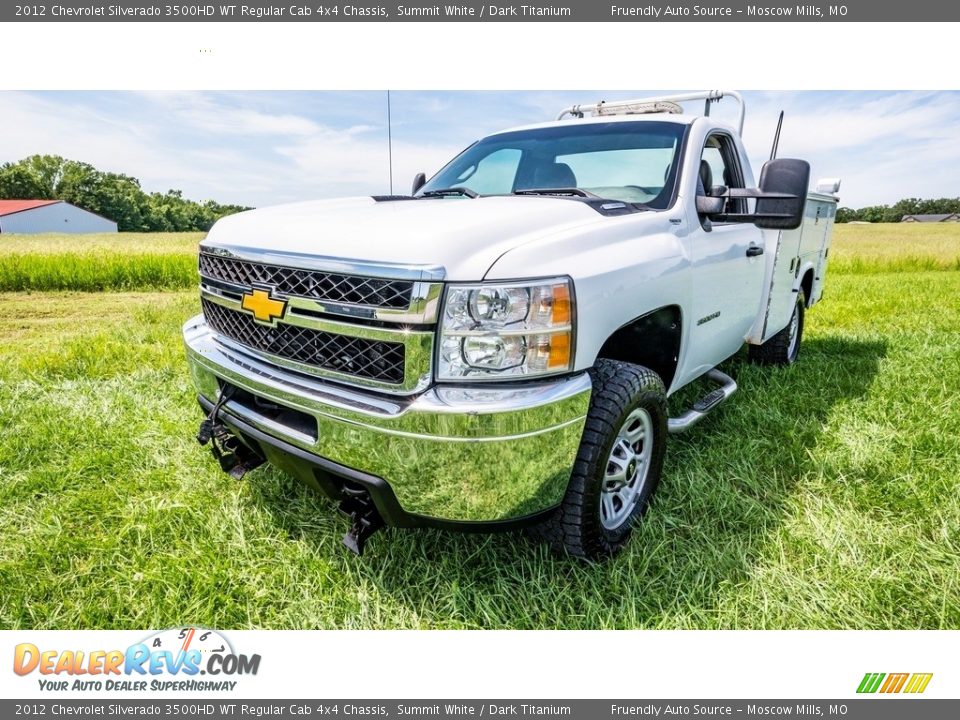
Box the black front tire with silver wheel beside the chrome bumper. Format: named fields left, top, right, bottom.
left=540, top=360, right=667, bottom=560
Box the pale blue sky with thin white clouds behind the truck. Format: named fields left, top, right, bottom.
left=0, top=89, right=960, bottom=207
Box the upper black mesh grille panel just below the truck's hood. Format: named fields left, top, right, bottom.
left=200, top=252, right=414, bottom=309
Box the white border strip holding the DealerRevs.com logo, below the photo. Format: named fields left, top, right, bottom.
left=0, top=630, right=960, bottom=701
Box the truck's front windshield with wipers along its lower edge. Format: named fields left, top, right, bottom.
left=417, top=122, right=686, bottom=210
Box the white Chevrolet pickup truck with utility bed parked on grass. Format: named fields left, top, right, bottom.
left=183, top=91, right=839, bottom=559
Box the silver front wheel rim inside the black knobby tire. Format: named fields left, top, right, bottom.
left=600, top=408, right=653, bottom=530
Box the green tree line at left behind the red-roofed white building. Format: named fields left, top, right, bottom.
left=0, top=155, right=249, bottom=232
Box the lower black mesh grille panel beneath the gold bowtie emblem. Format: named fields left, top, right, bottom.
left=201, top=298, right=406, bottom=385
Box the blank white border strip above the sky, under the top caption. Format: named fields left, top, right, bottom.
left=0, top=22, right=960, bottom=90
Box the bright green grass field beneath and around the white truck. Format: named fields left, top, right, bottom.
left=0, top=226, right=960, bottom=629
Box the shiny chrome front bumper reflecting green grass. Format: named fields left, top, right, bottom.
left=183, top=315, right=591, bottom=522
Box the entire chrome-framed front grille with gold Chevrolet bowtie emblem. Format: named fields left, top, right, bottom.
left=199, top=246, right=444, bottom=395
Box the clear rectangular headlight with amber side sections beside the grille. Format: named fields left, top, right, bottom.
left=437, top=278, right=574, bottom=380
